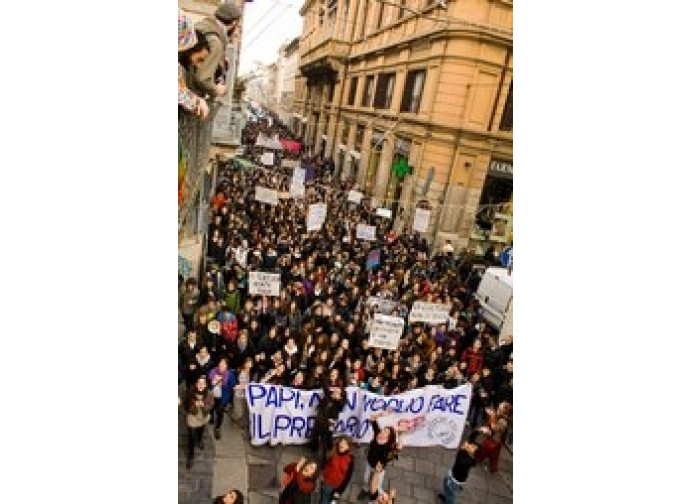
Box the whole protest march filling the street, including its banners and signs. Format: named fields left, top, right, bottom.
left=178, top=116, right=513, bottom=499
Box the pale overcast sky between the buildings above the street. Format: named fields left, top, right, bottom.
left=239, top=0, right=304, bottom=75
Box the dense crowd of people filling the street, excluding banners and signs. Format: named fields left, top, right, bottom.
left=179, top=112, right=513, bottom=504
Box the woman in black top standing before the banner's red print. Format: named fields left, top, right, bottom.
left=357, top=413, right=400, bottom=500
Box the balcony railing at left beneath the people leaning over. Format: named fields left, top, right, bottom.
left=177, top=103, right=220, bottom=234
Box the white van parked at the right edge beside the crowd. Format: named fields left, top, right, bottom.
left=475, top=268, right=513, bottom=338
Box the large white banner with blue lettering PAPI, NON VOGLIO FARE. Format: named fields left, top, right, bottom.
left=246, top=383, right=472, bottom=449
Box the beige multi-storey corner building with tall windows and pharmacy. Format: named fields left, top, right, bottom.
left=294, top=0, right=513, bottom=250
